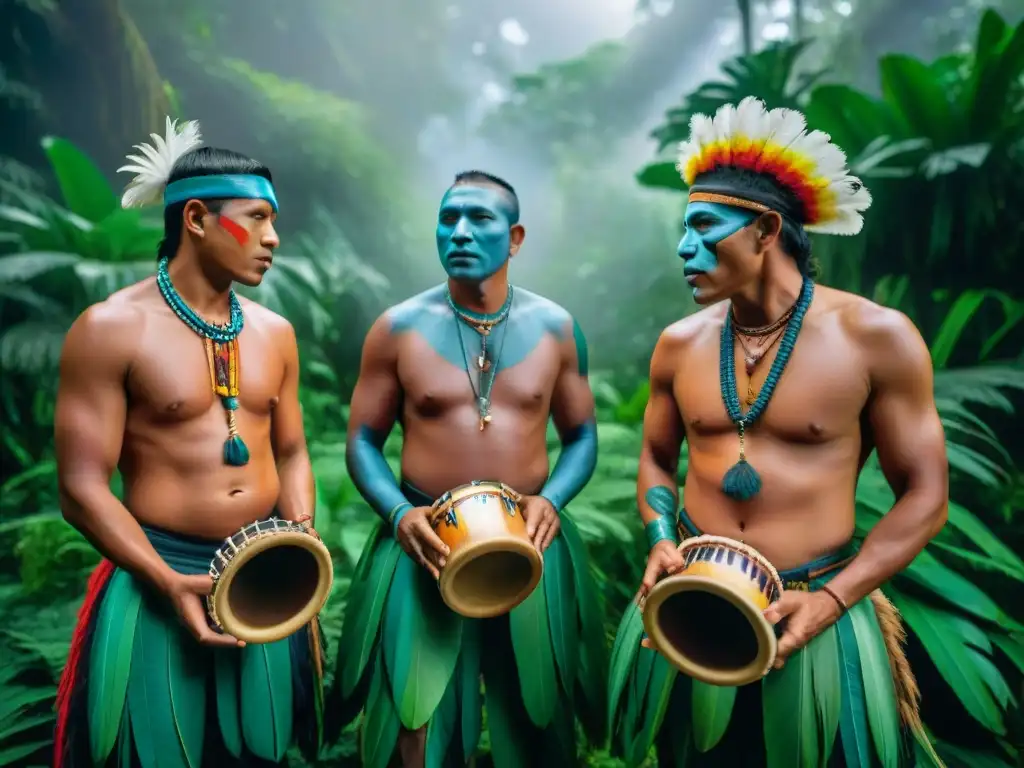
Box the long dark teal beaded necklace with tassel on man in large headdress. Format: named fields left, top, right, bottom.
left=719, top=278, right=814, bottom=502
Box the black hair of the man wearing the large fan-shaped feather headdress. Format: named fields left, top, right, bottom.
left=690, top=168, right=816, bottom=278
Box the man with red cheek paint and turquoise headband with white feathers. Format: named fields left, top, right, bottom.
left=54, top=120, right=323, bottom=768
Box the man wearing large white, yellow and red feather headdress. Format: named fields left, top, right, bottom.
left=609, top=98, right=948, bottom=768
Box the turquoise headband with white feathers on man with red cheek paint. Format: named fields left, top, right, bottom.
left=118, top=118, right=278, bottom=211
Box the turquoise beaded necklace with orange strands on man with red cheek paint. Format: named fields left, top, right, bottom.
left=157, top=258, right=249, bottom=467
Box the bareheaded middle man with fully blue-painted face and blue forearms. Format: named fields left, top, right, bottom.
left=328, top=171, right=605, bottom=768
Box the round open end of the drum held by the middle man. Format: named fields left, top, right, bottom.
left=438, top=537, right=544, bottom=618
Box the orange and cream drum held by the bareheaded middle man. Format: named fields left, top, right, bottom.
left=430, top=480, right=544, bottom=618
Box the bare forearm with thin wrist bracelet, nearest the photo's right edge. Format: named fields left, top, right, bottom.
left=828, top=490, right=948, bottom=606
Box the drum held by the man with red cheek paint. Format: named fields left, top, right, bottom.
left=207, top=517, right=334, bottom=644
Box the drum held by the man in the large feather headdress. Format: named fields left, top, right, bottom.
left=643, top=536, right=782, bottom=685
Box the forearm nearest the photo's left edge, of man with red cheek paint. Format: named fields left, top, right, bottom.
left=60, top=485, right=174, bottom=591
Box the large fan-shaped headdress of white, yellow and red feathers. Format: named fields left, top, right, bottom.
left=676, top=96, right=871, bottom=234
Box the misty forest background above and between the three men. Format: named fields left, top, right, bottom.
left=0, top=0, right=1024, bottom=344
